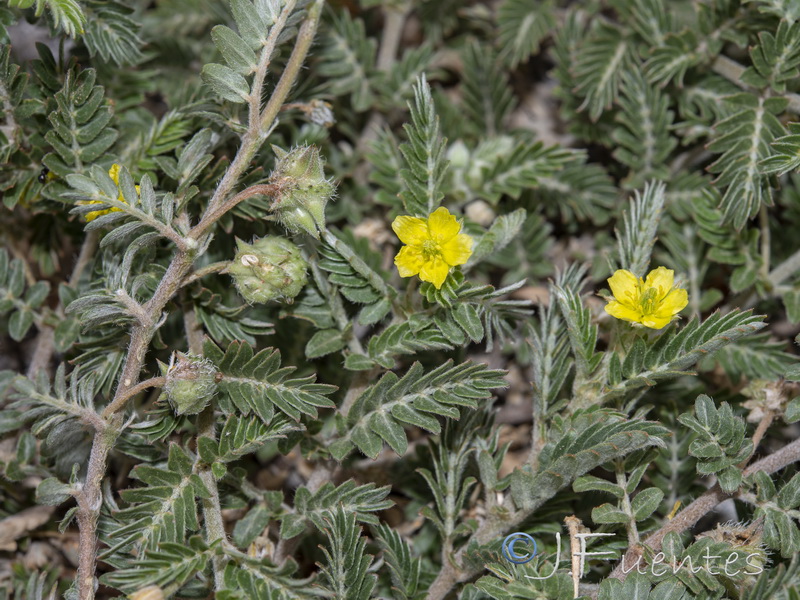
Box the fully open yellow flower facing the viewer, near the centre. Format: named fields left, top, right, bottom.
left=392, top=207, right=472, bottom=290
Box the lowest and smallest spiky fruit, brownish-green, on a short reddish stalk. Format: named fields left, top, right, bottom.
left=164, top=352, right=217, bottom=415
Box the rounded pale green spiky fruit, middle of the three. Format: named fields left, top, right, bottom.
left=227, top=235, right=308, bottom=304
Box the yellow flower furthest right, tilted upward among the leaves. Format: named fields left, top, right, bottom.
left=606, top=267, right=689, bottom=329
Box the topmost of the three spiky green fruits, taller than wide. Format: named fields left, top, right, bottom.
left=270, top=146, right=334, bottom=238
